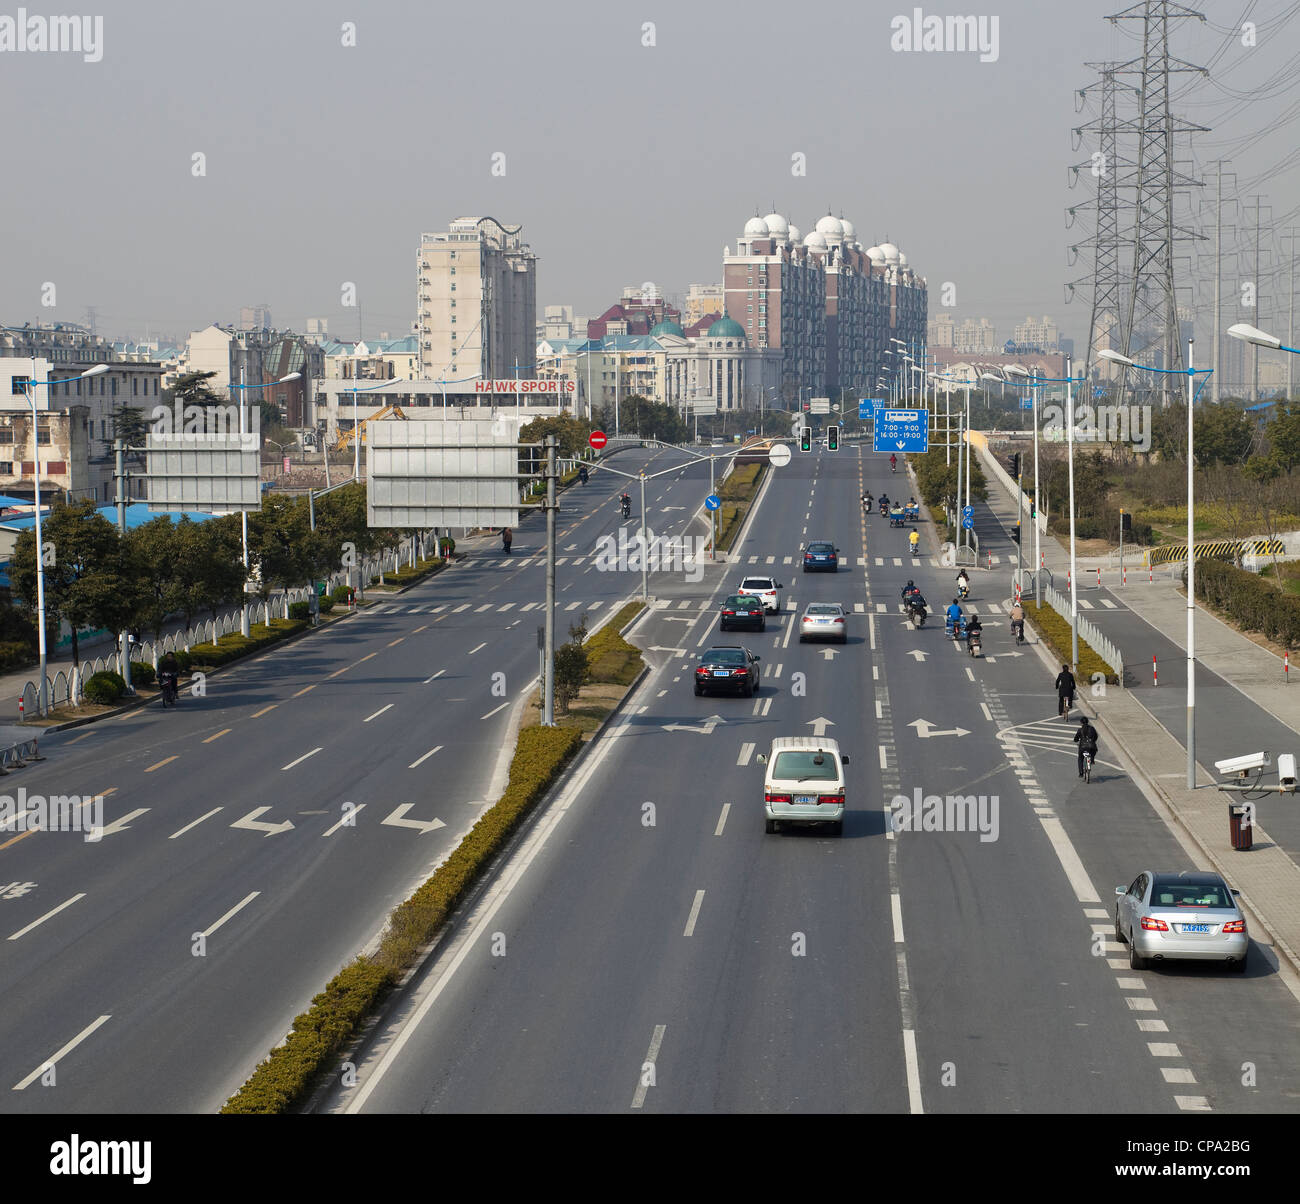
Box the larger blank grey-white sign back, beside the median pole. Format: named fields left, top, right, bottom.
left=365, top=419, right=519, bottom=528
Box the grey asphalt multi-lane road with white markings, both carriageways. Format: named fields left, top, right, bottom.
left=0, top=449, right=1300, bottom=1113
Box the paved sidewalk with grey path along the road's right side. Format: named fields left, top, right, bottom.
left=989, top=439, right=1300, bottom=974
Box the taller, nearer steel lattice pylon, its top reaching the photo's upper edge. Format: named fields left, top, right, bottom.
left=1106, top=0, right=1206, bottom=400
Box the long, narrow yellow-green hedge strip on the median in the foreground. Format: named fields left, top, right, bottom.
left=221, top=727, right=582, bottom=1114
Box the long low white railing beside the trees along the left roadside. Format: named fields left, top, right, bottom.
left=18, top=532, right=437, bottom=718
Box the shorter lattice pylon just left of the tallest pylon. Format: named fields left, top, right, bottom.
left=1066, top=62, right=1134, bottom=377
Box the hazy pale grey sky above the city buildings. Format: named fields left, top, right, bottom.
left=0, top=0, right=1300, bottom=353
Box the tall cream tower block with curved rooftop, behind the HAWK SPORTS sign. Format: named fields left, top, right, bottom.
left=416, top=217, right=537, bottom=381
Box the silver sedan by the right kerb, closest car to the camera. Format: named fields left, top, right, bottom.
left=1115, top=870, right=1251, bottom=973
